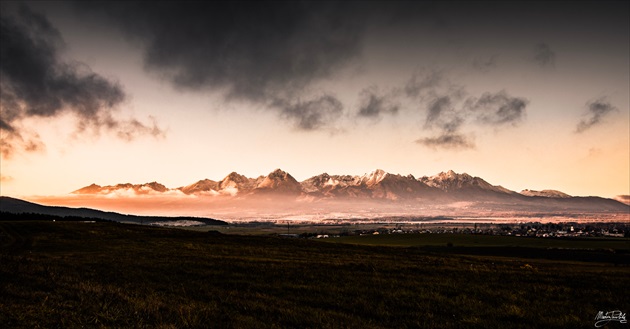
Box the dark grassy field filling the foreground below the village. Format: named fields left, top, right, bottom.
left=0, top=221, right=630, bottom=328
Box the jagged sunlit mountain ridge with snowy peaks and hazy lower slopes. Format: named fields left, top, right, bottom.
left=72, top=169, right=630, bottom=215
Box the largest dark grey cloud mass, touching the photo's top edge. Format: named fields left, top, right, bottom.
left=79, top=1, right=363, bottom=113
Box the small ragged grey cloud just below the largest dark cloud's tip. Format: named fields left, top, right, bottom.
left=274, top=95, right=343, bottom=131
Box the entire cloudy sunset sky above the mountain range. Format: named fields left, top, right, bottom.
left=0, top=1, right=630, bottom=197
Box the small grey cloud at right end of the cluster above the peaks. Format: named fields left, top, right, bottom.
left=465, top=91, right=529, bottom=126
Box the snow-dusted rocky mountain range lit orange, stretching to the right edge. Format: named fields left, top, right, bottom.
left=72, top=169, right=630, bottom=212
